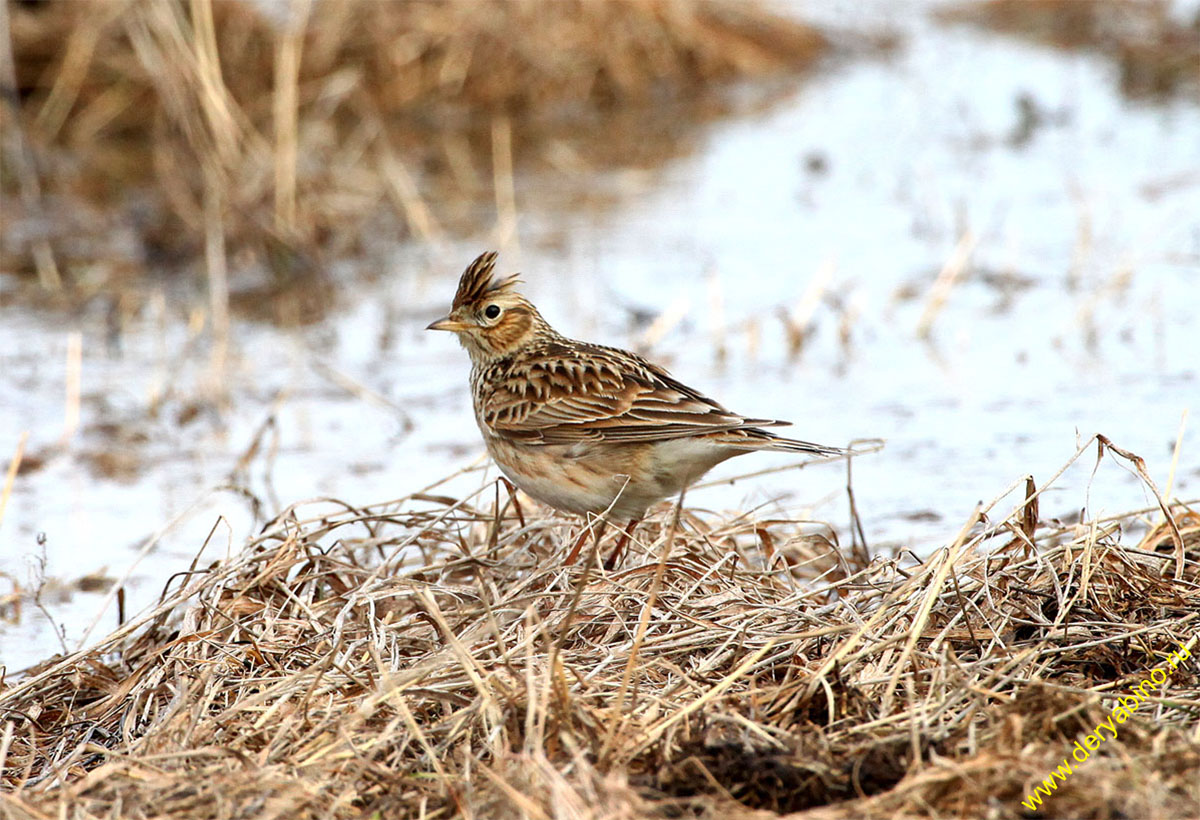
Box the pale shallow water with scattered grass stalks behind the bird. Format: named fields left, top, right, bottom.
left=0, top=4, right=1200, bottom=670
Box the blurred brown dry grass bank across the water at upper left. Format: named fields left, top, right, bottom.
left=0, top=0, right=827, bottom=315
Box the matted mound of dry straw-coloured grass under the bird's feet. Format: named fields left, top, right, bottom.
left=0, top=438, right=1200, bottom=819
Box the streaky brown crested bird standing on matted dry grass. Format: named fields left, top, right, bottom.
left=426, top=251, right=850, bottom=567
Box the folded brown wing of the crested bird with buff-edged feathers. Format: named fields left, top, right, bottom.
left=481, top=342, right=787, bottom=444
